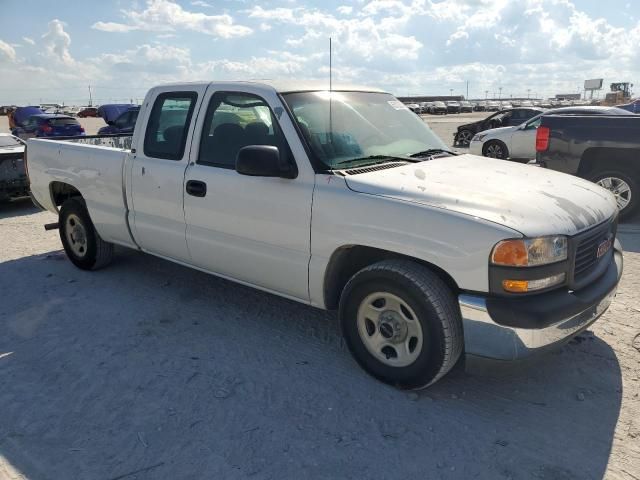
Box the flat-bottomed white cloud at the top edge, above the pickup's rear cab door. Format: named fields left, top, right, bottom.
left=92, top=0, right=252, bottom=38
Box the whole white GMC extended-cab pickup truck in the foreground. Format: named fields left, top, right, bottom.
left=27, top=82, right=622, bottom=388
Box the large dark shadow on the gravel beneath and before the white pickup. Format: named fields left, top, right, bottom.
left=0, top=251, right=622, bottom=479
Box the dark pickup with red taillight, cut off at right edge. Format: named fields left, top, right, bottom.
left=536, top=115, right=640, bottom=219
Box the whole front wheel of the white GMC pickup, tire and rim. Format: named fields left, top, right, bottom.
left=340, top=260, right=463, bottom=389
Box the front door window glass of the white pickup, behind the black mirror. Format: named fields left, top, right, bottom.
left=197, top=92, right=289, bottom=168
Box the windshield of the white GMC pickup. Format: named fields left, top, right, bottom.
left=283, top=91, right=447, bottom=169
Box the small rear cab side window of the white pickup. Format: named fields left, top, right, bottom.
left=144, top=92, right=198, bottom=160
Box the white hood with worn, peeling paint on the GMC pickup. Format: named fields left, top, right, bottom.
left=345, top=155, right=617, bottom=237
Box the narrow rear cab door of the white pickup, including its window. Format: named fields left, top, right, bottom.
left=127, top=85, right=206, bottom=262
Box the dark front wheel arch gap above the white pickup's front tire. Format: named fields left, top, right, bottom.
left=323, top=245, right=460, bottom=310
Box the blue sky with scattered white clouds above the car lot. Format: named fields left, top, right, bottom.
left=0, top=0, right=640, bottom=105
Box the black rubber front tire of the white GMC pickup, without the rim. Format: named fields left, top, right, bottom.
left=340, top=260, right=464, bottom=389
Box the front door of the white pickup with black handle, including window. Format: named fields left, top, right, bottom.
left=184, top=85, right=315, bottom=300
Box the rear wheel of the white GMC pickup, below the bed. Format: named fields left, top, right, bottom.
left=59, top=197, right=113, bottom=270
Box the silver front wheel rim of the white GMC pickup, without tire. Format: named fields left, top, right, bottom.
left=357, top=292, right=423, bottom=367
